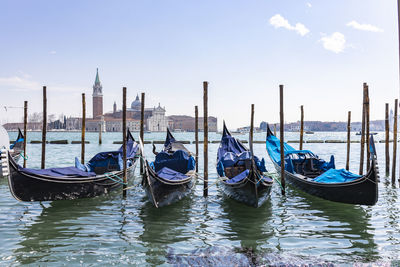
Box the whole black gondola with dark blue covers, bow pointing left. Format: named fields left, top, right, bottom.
left=4, top=131, right=139, bottom=201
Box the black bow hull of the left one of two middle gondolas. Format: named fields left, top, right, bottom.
left=142, top=164, right=196, bottom=207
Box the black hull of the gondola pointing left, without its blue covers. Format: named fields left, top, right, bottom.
left=8, top=156, right=136, bottom=201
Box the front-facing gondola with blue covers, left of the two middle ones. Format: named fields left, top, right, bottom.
left=142, top=129, right=196, bottom=208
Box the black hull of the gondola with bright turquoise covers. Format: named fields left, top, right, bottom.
left=272, top=160, right=378, bottom=206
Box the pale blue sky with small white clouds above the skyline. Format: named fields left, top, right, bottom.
left=0, top=0, right=399, bottom=128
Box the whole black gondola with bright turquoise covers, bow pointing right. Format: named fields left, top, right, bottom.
left=266, top=127, right=379, bottom=205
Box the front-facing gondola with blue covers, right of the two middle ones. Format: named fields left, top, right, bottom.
left=217, top=122, right=273, bottom=207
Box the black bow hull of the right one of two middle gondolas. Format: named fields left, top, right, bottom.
left=221, top=177, right=272, bottom=208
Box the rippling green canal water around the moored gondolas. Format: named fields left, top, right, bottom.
left=0, top=132, right=400, bottom=266
